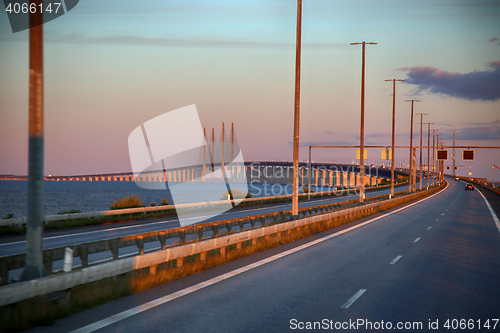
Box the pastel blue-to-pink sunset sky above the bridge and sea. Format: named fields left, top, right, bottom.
left=0, top=0, right=500, bottom=179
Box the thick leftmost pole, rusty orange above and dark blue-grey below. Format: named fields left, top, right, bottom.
left=21, top=0, right=47, bottom=281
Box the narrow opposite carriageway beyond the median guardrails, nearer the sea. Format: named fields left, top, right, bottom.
left=0, top=180, right=418, bottom=255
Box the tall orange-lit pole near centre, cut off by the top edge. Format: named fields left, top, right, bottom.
left=292, top=0, right=302, bottom=220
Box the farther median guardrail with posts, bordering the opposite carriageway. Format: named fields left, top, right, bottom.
left=0, top=183, right=430, bottom=285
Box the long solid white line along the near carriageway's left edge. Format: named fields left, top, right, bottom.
left=70, top=184, right=448, bottom=333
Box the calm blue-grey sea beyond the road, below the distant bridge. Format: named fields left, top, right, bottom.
left=0, top=180, right=332, bottom=218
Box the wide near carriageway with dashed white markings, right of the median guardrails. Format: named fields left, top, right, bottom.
left=33, top=181, right=500, bottom=332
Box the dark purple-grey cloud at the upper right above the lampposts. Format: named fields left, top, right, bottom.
left=399, top=60, right=500, bottom=101
